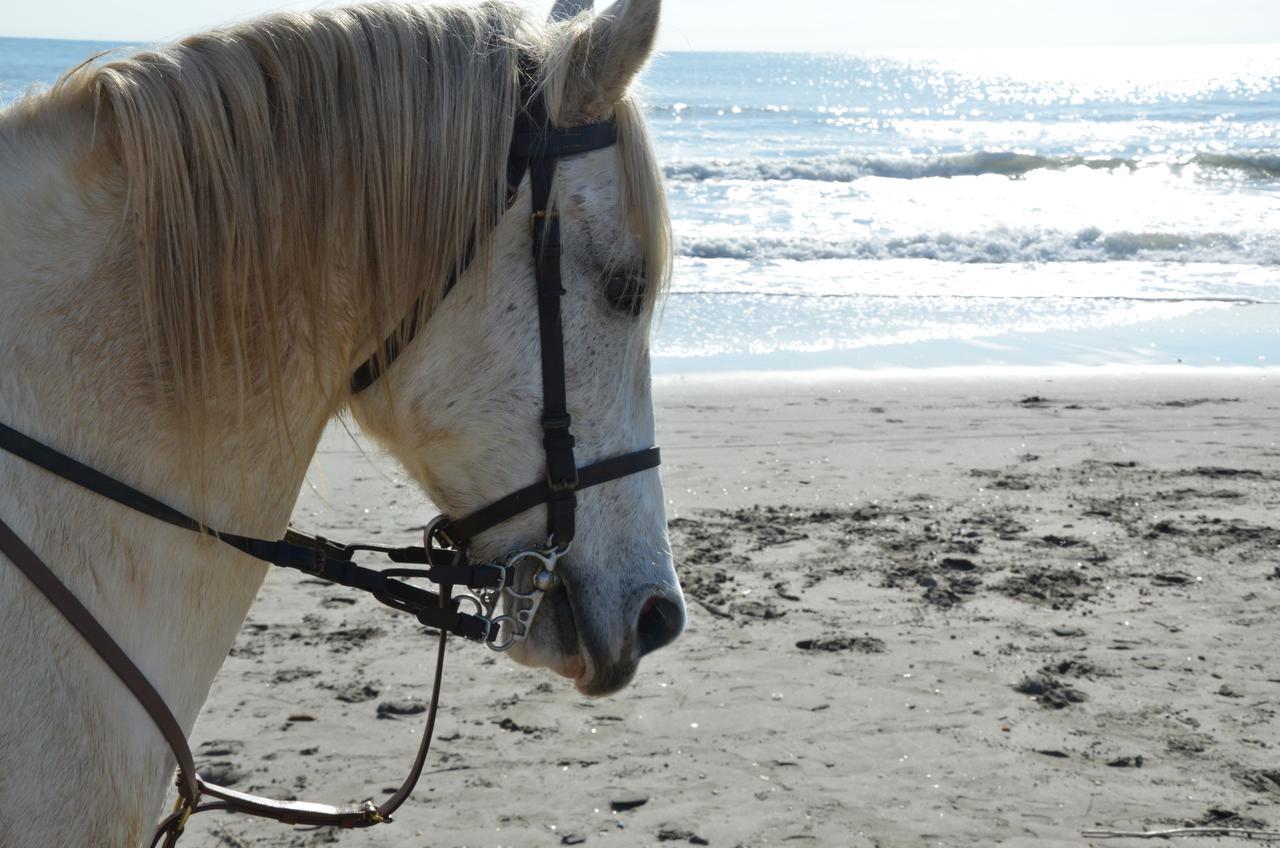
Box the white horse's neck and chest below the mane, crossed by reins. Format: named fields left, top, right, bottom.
left=0, top=94, right=345, bottom=845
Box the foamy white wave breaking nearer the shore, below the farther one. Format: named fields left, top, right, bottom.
left=680, top=227, right=1280, bottom=265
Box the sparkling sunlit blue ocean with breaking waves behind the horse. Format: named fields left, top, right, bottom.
left=0, top=38, right=1280, bottom=373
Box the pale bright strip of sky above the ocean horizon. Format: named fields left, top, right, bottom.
left=0, top=0, right=1280, bottom=53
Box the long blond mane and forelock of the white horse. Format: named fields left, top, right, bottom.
left=22, top=0, right=672, bottom=450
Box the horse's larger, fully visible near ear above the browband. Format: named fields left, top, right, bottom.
left=557, top=0, right=662, bottom=120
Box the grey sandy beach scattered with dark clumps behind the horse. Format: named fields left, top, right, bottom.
left=183, top=370, right=1280, bottom=848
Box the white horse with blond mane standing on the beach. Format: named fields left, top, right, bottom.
left=0, top=0, right=684, bottom=848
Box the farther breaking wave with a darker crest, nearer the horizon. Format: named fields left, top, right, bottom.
left=664, top=150, right=1280, bottom=182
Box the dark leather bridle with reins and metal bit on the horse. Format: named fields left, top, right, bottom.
left=0, top=76, right=659, bottom=848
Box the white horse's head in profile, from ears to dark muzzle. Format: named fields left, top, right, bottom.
left=352, top=0, right=685, bottom=694
